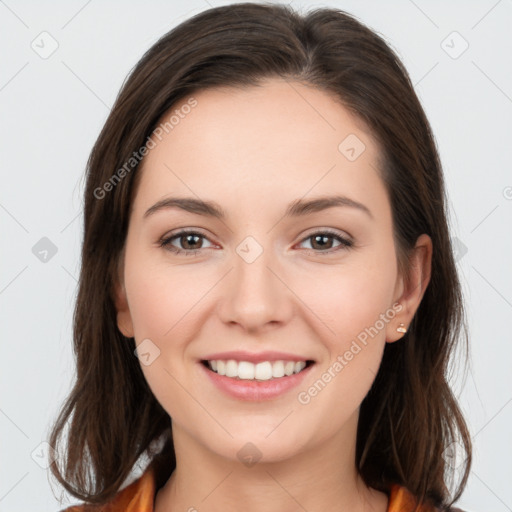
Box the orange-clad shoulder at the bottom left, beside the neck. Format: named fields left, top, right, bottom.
left=60, top=467, right=155, bottom=512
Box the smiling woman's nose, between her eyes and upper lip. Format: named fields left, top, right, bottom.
left=219, top=242, right=294, bottom=333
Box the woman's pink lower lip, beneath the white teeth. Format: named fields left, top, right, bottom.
left=199, top=363, right=314, bottom=402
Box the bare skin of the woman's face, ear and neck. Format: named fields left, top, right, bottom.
left=116, top=79, right=432, bottom=512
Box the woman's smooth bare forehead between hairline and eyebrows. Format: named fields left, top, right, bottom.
left=134, top=79, right=383, bottom=217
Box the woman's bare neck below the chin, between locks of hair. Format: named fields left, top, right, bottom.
left=155, top=417, right=388, bottom=512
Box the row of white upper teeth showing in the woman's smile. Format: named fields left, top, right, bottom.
left=208, top=359, right=306, bottom=380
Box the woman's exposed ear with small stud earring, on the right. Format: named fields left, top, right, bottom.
left=386, top=234, right=432, bottom=343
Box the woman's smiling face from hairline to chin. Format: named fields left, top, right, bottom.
left=117, top=80, right=424, bottom=461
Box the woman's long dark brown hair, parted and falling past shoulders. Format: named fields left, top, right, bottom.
left=49, top=3, right=471, bottom=507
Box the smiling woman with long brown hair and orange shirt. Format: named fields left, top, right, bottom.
left=50, top=3, right=471, bottom=512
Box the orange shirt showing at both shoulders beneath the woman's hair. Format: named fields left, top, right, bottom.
left=61, top=468, right=448, bottom=512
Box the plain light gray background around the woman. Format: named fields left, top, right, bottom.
left=0, top=0, right=512, bottom=512
